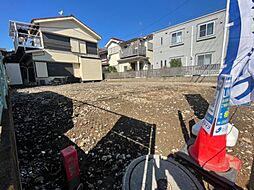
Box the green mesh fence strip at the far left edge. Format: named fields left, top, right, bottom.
left=0, top=56, right=8, bottom=123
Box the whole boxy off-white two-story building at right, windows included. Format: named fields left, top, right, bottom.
left=153, top=10, right=226, bottom=69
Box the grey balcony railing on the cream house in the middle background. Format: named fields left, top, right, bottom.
left=120, top=46, right=146, bottom=59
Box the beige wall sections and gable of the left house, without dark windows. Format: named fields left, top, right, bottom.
left=33, top=20, right=102, bottom=81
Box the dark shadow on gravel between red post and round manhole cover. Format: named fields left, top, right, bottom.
left=81, top=116, right=156, bottom=189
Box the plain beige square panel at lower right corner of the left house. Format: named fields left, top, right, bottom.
left=80, top=58, right=102, bottom=81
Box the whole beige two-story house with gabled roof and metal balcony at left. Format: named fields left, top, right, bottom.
left=9, top=15, right=102, bottom=84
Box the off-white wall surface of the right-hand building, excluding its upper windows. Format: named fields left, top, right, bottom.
left=153, top=10, right=225, bottom=69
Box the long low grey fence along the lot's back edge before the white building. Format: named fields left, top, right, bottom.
left=105, top=64, right=220, bottom=79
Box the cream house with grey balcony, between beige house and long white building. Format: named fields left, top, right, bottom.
left=106, top=35, right=153, bottom=72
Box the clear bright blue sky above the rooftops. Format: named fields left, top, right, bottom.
left=0, top=0, right=226, bottom=50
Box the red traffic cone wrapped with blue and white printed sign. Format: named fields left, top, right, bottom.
left=188, top=75, right=241, bottom=172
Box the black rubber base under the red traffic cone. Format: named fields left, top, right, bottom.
left=174, top=138, right=242, bottom=189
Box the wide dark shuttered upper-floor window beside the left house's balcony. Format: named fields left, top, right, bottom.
left=42, top=33, right=71, bottom=51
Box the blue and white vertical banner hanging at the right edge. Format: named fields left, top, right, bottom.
left=221, top=0, right=254, bottom=105
